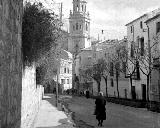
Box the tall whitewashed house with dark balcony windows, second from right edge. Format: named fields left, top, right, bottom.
left=126, top=9, right=160, bottom=100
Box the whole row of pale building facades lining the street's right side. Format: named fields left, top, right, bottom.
left=70, top=1, right=160, bottom=101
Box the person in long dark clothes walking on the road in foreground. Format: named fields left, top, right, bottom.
left=95, top=92, right=106, bottom=126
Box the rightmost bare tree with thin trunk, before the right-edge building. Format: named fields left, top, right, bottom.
left=135, top=34, right=160, bottom=101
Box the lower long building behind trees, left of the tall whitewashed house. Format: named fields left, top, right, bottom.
left=93, top=39, right=130, bottom=98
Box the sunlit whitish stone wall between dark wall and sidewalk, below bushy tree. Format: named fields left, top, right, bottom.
left=21, top=66, right=43, bottom=128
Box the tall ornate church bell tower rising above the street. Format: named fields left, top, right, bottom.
left=68, top=0, right=91, bottom=55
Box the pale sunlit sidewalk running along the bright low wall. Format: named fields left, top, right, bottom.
left=33, top=94, right=74, bottom=128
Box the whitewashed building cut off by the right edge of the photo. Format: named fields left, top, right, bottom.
left=146, top=13, right=160, bottom=101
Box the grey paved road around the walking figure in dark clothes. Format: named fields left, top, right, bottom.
left=62, top=97, right=160, bottom=128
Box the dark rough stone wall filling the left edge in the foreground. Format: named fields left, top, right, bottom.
left=0, top=0, right=23, bottom=128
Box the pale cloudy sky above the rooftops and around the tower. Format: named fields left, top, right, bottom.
left=29, top=0, right=160, bottom=39
